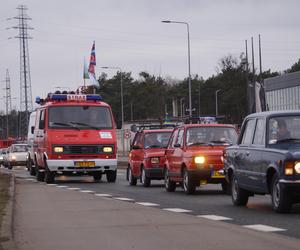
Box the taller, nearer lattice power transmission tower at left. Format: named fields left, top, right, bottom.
left=13, top=5, right=33, bottom=137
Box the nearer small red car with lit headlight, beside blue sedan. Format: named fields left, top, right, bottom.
left=165, top=124, right=238, bottom=194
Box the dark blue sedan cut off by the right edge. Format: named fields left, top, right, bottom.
left=224, top=111, right=300, bottom=213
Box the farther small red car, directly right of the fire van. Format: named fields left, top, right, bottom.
left=127, top=129, right=173, bottom=187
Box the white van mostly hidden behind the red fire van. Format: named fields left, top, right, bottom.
left=26, top=111, right=36, bottom=175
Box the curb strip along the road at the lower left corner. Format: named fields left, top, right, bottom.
left=0, top=174, right=16, bottom=250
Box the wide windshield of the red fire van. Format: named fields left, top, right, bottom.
left=48, top=106, right=112, bottom=129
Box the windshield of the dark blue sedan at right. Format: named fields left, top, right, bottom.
left=269, top=115, right=300, bottom=144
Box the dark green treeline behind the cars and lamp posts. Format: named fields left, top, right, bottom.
left=94, top=56, right=300, bottom=124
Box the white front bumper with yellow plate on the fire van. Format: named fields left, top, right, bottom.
left=47, top=159, right=117, bottom=172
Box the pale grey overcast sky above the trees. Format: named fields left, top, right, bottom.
left=0, top=0, right=300, bottom=110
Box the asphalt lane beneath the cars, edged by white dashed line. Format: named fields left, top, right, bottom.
left=4, top=167, right=300, bottom=238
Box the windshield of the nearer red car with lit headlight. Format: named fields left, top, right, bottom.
left=186, top=126, right=238, bottom=146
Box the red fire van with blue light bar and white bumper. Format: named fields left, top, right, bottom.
left=33, top=92, right=117, bottom=183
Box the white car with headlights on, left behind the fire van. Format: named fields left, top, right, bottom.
left=7, top=144, right=28, bottom=169
